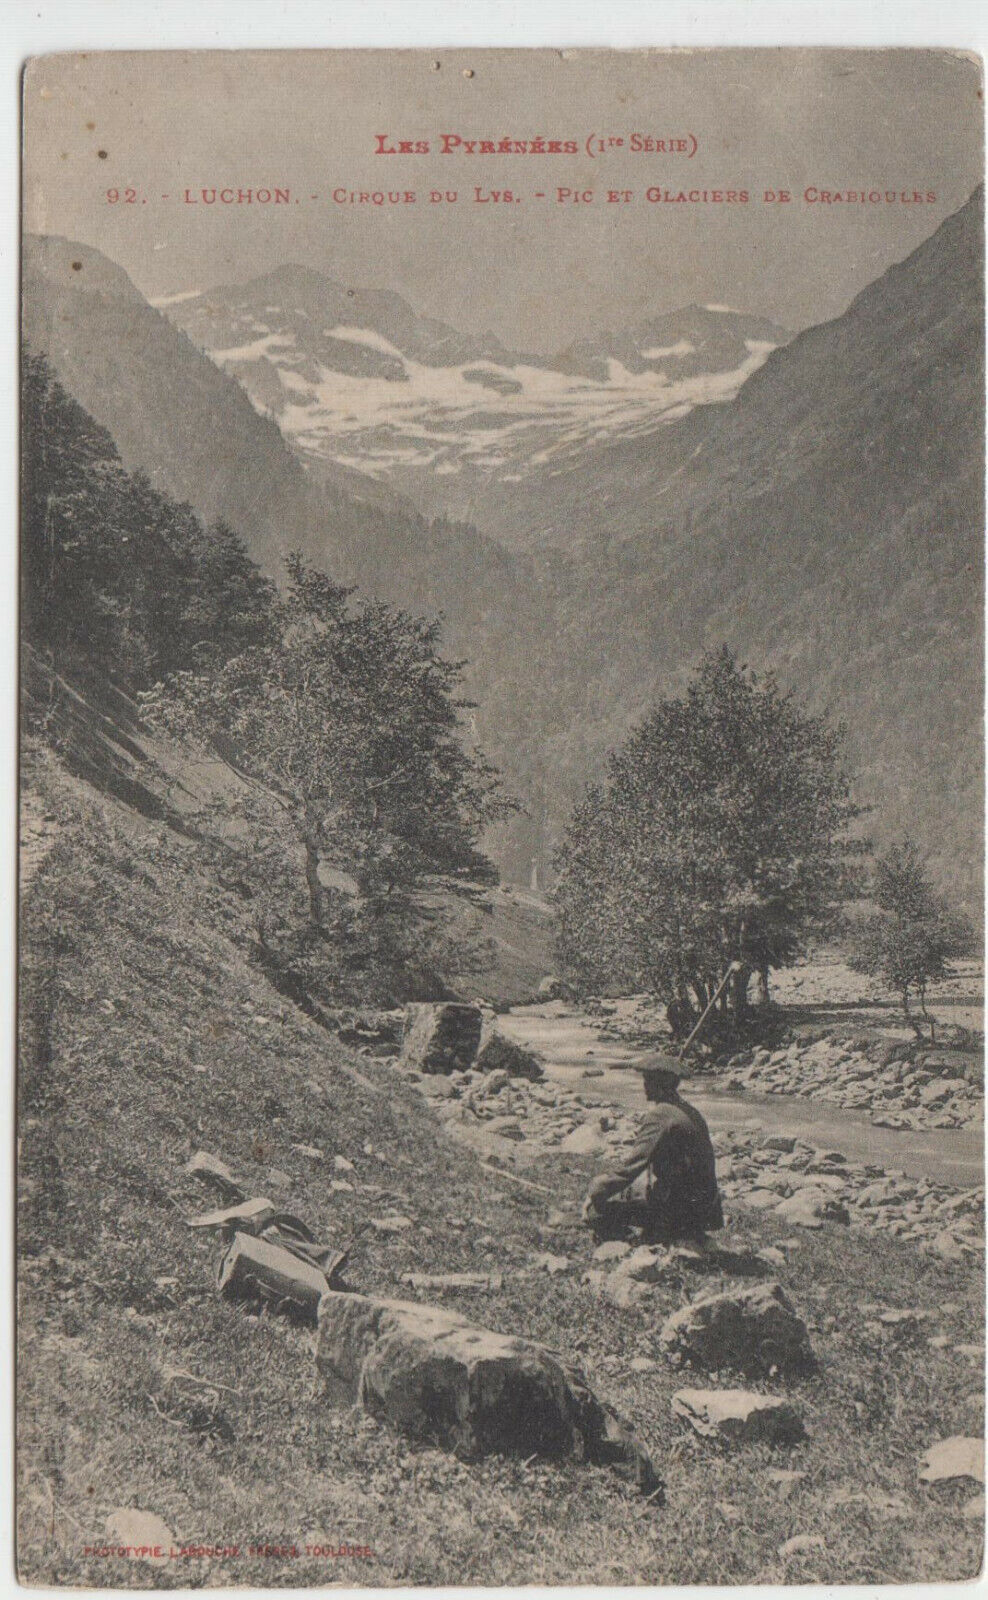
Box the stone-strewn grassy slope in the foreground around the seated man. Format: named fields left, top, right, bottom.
left=19, top=762, right=983, bottom=1586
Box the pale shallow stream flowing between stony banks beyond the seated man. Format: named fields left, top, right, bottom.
left=500, top=1005, right=985, bottom=1186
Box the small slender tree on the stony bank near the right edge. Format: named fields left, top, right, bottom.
left=849, top=840, right=975, bottom=1040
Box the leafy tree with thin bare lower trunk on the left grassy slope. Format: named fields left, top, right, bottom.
left=141, top=557, right=510, bottom=998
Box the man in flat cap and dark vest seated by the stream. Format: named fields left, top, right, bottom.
left=584, top=1054, right=724, bottom=1243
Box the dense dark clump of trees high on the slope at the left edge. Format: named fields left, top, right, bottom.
left=21, top=350, right=275, bottom=690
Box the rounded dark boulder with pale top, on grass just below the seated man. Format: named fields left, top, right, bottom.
left=659, top=1283, right=815, bottom=1373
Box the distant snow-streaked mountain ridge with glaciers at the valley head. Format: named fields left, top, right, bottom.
left=165, top=266, right=790, bottom=524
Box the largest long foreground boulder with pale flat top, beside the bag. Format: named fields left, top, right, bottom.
left=315, top=1290, right=657, bottom=1493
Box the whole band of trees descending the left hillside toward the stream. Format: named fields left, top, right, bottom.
left=22, top=352, right=527, bottom=1008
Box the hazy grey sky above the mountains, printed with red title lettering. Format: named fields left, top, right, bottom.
left=24, top=50, right=983, bottom=350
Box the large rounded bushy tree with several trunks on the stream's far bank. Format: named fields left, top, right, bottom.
left=555, top=648, right=866, bottom=1029
